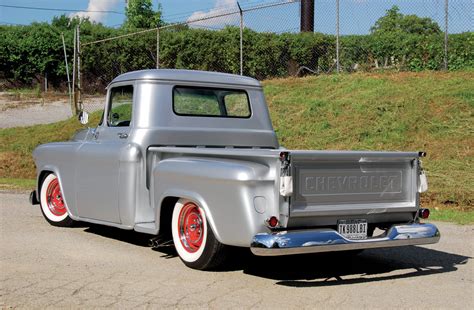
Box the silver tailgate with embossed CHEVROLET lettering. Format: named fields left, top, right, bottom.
left=290, top=151, right=418, bottom=217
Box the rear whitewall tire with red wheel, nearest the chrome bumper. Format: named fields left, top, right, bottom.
left=171, top=199, right=228, bottom=270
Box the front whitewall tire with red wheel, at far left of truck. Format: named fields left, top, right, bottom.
left=40, top=173, right=74, bottom=227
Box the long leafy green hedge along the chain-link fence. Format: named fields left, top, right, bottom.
left=0, top=13, right=474, bottom=92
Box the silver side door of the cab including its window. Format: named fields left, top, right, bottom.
left=76, top=85, right=133, bottom=223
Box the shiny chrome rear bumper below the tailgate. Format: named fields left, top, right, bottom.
left=250, top=224, right=441, bottom=256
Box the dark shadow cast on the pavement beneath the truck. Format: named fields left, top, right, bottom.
left=79, top=224, right=472, bottom=287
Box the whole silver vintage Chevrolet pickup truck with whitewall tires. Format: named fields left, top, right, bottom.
left=30, top=70, right=440, bottom=269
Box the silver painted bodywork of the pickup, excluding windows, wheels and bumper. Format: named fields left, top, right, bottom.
left=33, top=70, right=436, bottom=251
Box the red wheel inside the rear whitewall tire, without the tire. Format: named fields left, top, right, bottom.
left=178, top=203, right=204, bottom=253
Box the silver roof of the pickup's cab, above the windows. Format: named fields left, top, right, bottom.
left=110, top=69, right=261, bottom=87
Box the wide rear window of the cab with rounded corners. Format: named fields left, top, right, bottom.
left=173, top=86, right=251, bottom=118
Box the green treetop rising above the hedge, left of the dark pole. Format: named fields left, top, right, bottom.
left=124, top=0, right=163, bottom=30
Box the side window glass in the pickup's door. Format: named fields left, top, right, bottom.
left=107, top=86, right=133, bottom=127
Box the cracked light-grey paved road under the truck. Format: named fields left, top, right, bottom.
left=0, top=193, right=474, bottom=309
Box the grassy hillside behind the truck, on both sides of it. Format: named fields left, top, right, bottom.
left=0, top=71, right=474, bottom=220
